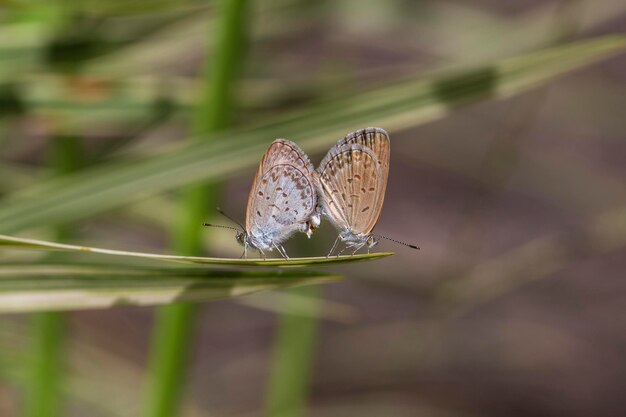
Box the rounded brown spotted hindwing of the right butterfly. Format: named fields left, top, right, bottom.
left=317, top=143, right=388, bottom=234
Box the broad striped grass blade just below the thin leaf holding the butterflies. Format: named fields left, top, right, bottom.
left=0, top=264, right=340, bottom=313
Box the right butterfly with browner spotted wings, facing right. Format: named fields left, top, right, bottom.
left=315, top=127, right=418, bottom=256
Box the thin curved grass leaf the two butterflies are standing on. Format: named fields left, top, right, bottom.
left=0, top=235, right=393, bottom=264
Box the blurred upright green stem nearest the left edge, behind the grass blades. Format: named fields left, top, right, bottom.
left=24, top=137, right=83, bottom=417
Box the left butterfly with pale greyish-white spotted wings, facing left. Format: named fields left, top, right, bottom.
left=205, top=139, right=320, bottom=259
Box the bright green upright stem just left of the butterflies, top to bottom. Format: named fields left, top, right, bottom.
left=145, top=0, right=248, bottom=417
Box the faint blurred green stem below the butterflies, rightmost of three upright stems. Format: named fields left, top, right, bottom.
left=265, top=286, right=321, bottom=417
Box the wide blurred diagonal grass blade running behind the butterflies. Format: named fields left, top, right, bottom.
left=0, top=36, right=626, bottom=233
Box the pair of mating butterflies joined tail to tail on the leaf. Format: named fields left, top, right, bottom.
left=207, top=127, right=417, bottom=258
